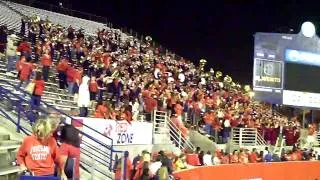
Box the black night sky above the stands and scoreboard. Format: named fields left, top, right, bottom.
left=43, top=0, right=320, bottom=84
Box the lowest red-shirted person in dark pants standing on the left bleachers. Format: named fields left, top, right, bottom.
left=30, top=72, right=45, bottom=109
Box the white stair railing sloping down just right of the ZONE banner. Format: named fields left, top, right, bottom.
left=152, top=110, right=195, bottom=150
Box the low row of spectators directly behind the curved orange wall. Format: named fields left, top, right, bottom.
left=115, top=145, right=320, bottom=180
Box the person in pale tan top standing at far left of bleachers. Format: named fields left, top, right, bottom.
left=6, top=34, right=17, bottom=75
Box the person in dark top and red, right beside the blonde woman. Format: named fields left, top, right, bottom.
left=60, top=125, right=80, bottom=180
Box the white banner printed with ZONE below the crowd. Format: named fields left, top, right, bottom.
left=68, top=117, right=152, bottom=145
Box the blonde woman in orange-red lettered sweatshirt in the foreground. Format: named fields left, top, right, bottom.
left=17, top=119, right=67, bottom=180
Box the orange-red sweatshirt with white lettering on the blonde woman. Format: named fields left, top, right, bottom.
left=17, top=135, right=63, bottom=176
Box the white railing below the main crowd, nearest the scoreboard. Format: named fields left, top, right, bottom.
left=231, top=128, right=267, bottom=146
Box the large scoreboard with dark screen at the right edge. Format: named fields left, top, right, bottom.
left=253, top=33, right=320, bottom=108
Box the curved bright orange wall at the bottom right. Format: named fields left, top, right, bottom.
left=175, top=161, right=320, bottom=180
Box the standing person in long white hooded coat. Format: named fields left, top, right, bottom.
left=78, top=75, right=90, bottom=117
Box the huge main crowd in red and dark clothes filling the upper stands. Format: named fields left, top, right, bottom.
left=1, top=14, right=310, bottom=144
